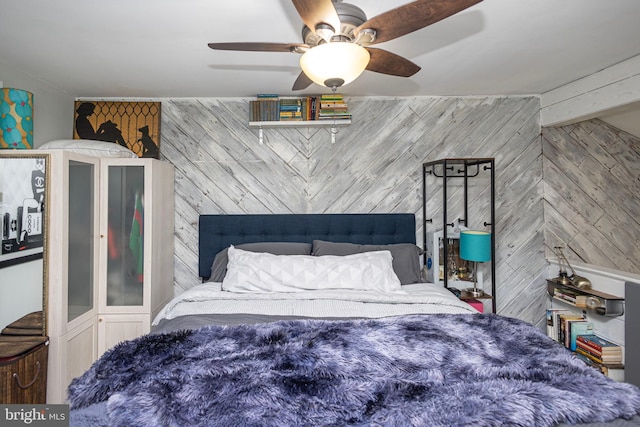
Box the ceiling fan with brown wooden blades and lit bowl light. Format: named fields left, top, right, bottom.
left=209, top=0, right=482, bottom=90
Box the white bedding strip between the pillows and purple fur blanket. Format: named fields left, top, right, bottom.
left=153, top=283, right=477, bottom=325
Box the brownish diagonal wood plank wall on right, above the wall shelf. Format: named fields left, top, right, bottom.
left=542, top=119, right=640, bottom=274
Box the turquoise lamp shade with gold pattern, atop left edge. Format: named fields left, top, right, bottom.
left=0, top=88, right=33, bottom=148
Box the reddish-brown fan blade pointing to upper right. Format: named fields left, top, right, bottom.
left=355, top=0, right=482, bottom=44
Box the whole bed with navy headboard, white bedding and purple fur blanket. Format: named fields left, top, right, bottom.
left=69, top=214, right=640, bottom=427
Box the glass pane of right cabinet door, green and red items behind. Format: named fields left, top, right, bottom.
left=106, top=165, right=144, bottom=306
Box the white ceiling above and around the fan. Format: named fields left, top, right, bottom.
left=0, top=0, right=640, bottom=134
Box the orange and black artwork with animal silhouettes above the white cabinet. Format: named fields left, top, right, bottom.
left=73, top=101, right=161, bottom=159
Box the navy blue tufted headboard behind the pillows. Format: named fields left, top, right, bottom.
left=198, top=213, right=416, bottom=279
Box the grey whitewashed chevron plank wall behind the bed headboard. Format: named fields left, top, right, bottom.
left=160, top=97, right=546, bottom=324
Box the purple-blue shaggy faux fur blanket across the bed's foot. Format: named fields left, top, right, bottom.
left=69, top=314, right=640, bottom=427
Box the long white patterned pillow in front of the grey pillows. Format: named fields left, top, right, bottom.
left=222, top=246, right=401, bottom=292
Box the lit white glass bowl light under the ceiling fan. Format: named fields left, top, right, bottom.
left=300, top=42, right=371, bottom=87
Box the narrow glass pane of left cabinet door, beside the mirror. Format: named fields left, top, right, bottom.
left=67, top=160, right=97, bottom=322
